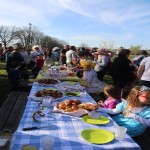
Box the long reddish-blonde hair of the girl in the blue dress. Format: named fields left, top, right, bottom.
left=123, top=86, right=141, bottom=114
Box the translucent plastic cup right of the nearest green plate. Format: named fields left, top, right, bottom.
left=115, top=126, right=127, bottom=140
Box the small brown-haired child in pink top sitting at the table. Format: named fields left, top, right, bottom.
left=98, top=85, right=121, bottom=109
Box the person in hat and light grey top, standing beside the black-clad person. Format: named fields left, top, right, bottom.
left=94, top=49, right=110, bottom=81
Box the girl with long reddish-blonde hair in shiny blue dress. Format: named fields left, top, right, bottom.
left=99, top=86, right=150, bottom=148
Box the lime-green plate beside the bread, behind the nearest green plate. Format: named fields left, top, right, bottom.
left=82, top=115, right=110, bottom=124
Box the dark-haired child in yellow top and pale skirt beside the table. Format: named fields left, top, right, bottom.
left=77, top=51, right=104, bottom=93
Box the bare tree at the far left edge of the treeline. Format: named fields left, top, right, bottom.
left=0, top=25, right=16, bottom=48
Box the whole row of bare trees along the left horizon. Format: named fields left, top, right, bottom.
left=0, top=25, right=67, bottom=49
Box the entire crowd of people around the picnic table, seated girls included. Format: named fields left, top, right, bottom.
left=0, top=45, right=150, bottom=149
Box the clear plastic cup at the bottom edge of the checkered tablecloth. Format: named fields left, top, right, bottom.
left=41, top=135, right=54, bottom=150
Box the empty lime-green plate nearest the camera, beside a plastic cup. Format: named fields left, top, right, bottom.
left=81, top=129, right=114, bottom=144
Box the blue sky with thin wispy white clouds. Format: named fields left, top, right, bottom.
left=0, top=0, right=150, bottom=49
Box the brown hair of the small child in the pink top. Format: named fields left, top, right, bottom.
left=104, top=85, right=121, bottom=101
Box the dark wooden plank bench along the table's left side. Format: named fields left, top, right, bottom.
left=0, top=92, right=29, bottom=133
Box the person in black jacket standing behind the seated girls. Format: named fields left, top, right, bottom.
left=110, top=49, right=135, bottom=89
